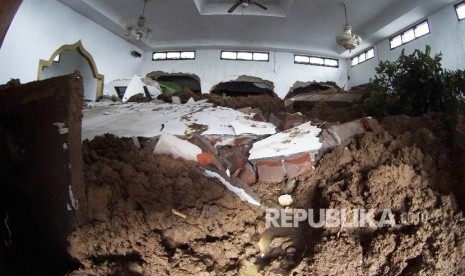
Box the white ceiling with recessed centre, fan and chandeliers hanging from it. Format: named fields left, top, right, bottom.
left=58, top=0, right=457, bottom=58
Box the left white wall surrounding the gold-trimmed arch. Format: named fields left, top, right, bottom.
left=0, top=0, right=142, bottom=101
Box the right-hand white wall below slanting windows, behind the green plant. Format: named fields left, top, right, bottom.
left=349, top=2, right=465, bottom=86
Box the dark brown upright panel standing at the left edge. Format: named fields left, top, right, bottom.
left=0, top=72, right=87, bottom=269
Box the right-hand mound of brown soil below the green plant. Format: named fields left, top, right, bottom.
left=293, top=115, right=465, bottom=275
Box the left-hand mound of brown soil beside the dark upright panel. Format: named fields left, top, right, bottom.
left=69, top=135, right=264, bottom=275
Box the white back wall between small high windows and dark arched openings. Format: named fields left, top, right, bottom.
left=142, top=50, right=347, bottom=98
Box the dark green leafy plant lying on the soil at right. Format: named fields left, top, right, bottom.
left=363, top=45, right=465, bottom=116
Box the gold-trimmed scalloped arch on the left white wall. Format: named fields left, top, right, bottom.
left=37, top=41, right=104, bottom=101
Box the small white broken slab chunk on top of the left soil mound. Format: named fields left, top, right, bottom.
left=153, top=134, right=202, bottom=161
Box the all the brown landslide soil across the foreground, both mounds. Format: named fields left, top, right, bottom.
left=69, top=115, right=465, bottom=275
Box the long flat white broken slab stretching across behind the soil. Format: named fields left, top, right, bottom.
left=82, top=101, right=276, bottom=140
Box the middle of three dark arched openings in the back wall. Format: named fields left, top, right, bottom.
left=211, top=75, right=276, bottom=97
